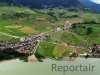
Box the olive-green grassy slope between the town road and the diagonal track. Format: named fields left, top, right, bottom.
left=51, top=31, right=85, bottom=45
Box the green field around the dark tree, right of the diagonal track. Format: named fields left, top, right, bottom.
left=71, top=24, right=100, bottom=46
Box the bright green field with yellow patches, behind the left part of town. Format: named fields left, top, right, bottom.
left=0, top=18, right=52, bottom=36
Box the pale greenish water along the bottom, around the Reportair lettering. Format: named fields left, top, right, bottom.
left=0, top=58, right=100, bottom=75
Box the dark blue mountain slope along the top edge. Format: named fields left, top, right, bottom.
left=0, top=0, right=81, bottom=8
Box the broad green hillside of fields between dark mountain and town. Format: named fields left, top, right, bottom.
left=0, top=6, right=100, bottom=42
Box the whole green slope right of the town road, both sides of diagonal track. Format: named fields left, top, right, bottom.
left=50, top=24, right=100, bottom=46
